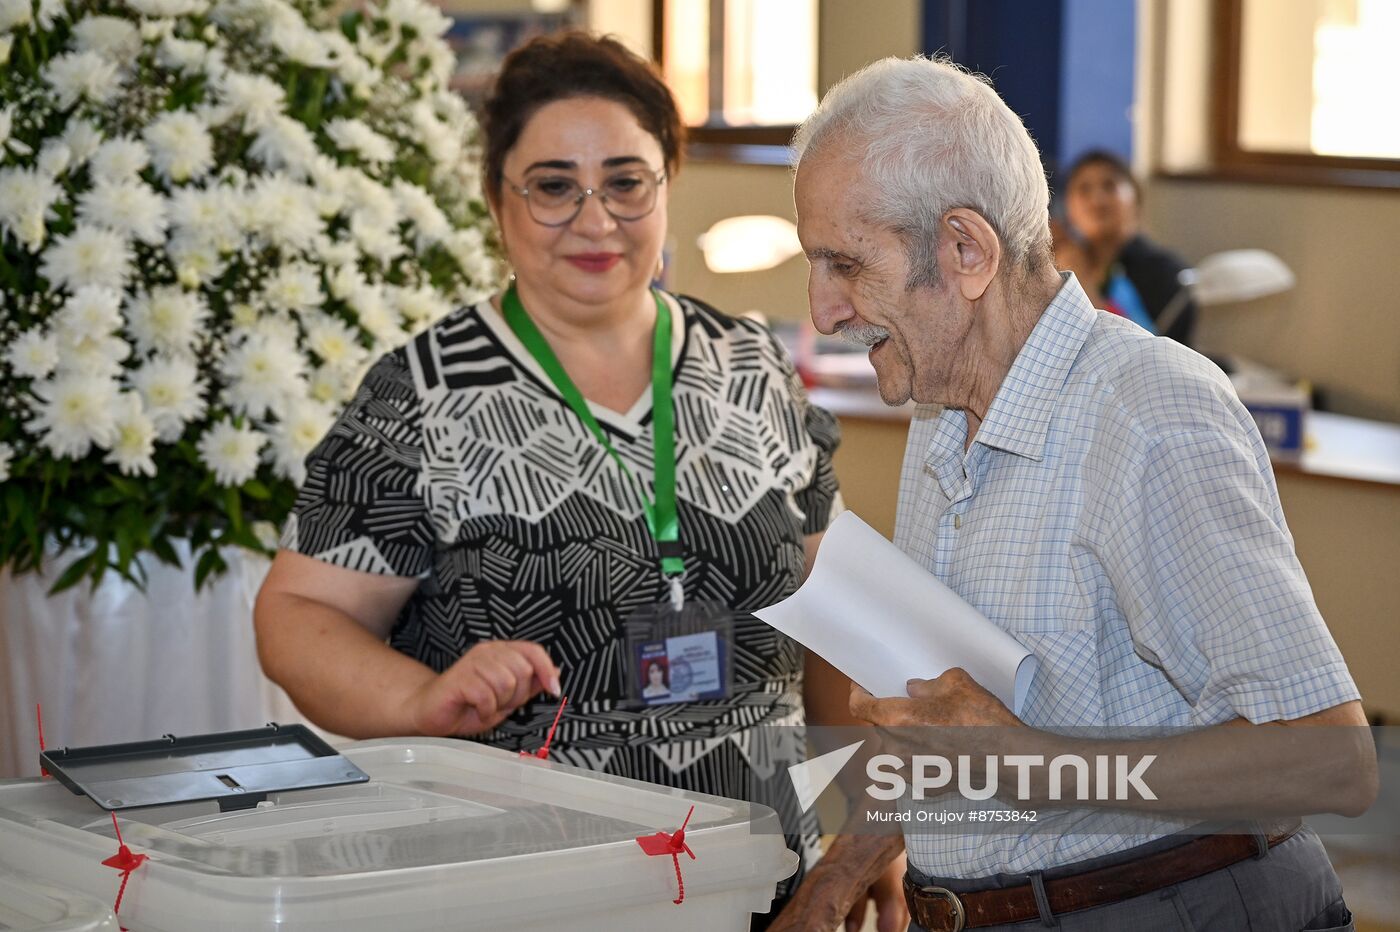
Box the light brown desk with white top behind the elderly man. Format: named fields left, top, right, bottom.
left=811, top=388, right=1400, bottom=723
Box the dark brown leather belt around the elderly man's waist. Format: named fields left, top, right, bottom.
left=904, top=824, right=1301, bottom=932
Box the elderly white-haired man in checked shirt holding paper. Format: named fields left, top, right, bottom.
left=784, top=59, right=1376, bottom=932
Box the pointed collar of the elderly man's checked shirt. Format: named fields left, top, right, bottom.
left=973, top=271, right=1099, bottom=462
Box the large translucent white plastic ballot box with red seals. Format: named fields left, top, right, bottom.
left=0, top=739, right=798, bottom=932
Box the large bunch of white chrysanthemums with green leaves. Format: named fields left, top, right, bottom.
left=0, top=0, right=500, bottom=588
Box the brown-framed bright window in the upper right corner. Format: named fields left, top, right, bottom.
left=1215, top=0, right=1400, bottom=188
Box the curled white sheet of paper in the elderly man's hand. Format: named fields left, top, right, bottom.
left=755, top=511, right=1036, bottom=715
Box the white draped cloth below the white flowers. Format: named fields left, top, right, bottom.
left=0, top=549, right=302, bottom=778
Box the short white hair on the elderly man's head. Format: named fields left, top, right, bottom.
left=792, top=56, right=1051, bottom=287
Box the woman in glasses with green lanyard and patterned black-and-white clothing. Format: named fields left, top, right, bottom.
left=256, top=32, right=903, bottom=910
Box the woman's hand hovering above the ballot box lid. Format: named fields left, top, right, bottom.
left=409, top=641, right=560, bottom=736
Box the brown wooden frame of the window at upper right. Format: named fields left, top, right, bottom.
left=1211, top=0, right=1400, bottom=189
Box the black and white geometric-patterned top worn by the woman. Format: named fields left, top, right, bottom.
left=283, top=295, right=841, bottom=884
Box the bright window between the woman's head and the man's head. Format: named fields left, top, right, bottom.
left=654, top=0, right=818, bottom=146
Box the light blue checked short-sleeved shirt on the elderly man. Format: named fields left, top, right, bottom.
left=895, top=274, right=1359, bottom=879
